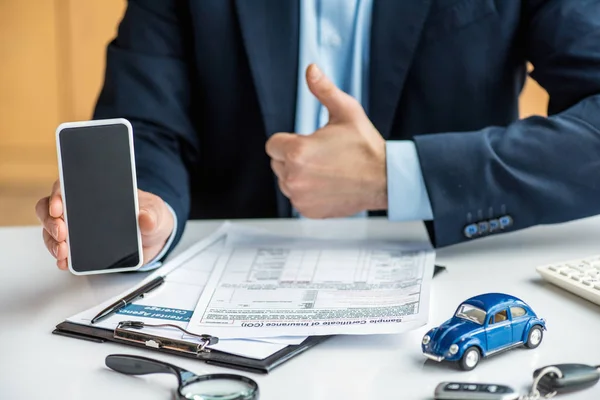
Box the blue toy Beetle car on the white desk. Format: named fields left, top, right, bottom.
left=421, top=293, right=546, bottom=371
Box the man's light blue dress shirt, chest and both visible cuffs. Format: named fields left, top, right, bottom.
left=143, top=0, right=433, bottom=271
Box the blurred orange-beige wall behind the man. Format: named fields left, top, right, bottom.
left=0, top=0, right=547, bottom=225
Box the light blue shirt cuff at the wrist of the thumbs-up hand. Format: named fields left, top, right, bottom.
left=385, top=140, right=433, bottom=221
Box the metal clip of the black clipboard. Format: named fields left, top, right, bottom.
left=113, top=321, right=219, bottom=358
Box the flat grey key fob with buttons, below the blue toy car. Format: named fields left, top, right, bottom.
left=434, top=382, right=519, bottom=400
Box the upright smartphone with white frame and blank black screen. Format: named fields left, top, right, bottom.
left=56, top=118, right=144, bottom=275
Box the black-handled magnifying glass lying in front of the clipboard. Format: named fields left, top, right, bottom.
left=105, top=354, right=258, bottom=400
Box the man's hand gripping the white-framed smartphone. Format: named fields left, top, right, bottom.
left=35, top=180, right=174, bottom=270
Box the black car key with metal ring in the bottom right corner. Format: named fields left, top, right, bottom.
left=533, top=364, right=600, bottom=393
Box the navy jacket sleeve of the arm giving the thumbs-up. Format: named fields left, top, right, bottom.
left=414, top=0, right=600, bottom=246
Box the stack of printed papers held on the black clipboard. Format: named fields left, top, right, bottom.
left=67, top=223, right=434, bottom=359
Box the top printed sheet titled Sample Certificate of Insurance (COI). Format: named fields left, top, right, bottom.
left=188, top=233, right=435, bottom=338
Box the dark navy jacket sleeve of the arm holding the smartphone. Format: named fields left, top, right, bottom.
left=94, top=0, right=198, bottom=256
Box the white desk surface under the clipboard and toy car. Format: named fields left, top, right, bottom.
left=0, top=217, right=600, bottom=400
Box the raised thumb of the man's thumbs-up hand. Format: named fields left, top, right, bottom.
left=306, top=64, right=363, bottom=121
